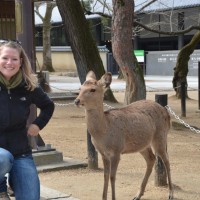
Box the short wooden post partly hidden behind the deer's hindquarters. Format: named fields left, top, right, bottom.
left=155, top=94, right=167, bottom=186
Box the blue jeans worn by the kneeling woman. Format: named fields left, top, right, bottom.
left=0, top=148, right=40, bottom=200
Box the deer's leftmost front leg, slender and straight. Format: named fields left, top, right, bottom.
left=102, top=156, right=110, bottom=200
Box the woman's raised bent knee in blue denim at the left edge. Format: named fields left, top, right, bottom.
left=0, top=148, right=14, bottom=176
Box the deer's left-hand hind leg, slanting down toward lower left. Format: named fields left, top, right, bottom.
left=134, top=147, right=156, bottom=200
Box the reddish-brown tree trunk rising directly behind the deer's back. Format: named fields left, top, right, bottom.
left=112, top=0, right=146, bottom=104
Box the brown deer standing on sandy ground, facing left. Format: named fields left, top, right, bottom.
left=74, top=71, right=173, bottom=200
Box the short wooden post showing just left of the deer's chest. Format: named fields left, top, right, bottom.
left=87, top=131, right=98, bottom=169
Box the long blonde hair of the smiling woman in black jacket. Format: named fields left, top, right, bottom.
left=0, top=41, right=38, bottom=91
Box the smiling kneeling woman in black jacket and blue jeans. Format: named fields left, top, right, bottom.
left=0, top=40, right=54, bottom=200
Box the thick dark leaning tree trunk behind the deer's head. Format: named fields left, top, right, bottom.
left=57, top=0, right=116, bottom=102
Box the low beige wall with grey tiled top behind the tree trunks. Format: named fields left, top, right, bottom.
left=36, top=46, right=108, bottom=72
